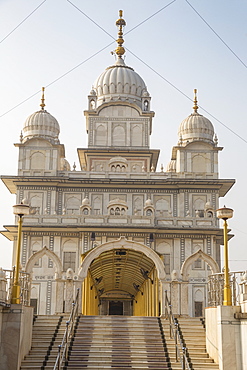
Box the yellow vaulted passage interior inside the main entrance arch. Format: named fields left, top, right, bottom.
left=82, top=248, right=159, bottom=316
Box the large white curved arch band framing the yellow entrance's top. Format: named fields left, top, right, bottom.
left=78, top=236, right=166, bottom=280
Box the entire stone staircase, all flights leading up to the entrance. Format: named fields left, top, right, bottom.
left=21, top=315, right=219, bottom=370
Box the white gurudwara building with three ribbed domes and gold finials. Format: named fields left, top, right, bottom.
left=2, top=11, right=234, bottom=316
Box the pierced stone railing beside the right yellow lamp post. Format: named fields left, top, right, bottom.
left=208, top=271, right=246, bottom=306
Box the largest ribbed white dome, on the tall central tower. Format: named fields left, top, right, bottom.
left=94, top=58, right=147, bottom=107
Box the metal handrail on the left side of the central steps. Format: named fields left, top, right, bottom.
left=53, top=288, right=80, bottom=370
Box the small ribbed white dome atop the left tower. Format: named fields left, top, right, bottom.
left=23, top=109, right=60, bottom=143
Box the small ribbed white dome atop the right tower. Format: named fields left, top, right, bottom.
left=178, top=112, right=214, bottom=144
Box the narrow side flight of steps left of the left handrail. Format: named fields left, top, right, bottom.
left=21, top=315, right=68, bottom=370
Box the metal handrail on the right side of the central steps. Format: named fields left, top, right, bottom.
left=165, top=290, right=193, bottom=370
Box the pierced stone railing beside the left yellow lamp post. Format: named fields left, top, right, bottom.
left=0, top=268, right=31, bottom=307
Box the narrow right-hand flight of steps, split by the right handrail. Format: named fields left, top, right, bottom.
left=160, top=317, right=219, bottom=370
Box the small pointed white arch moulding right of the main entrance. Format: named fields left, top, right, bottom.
left=181, top=249, right=220, bottom=281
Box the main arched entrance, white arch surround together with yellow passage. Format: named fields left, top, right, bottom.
left=79, top=237, right=165, bottom=316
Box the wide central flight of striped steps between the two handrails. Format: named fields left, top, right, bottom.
left=67, top=316, right=171, bottom=370
